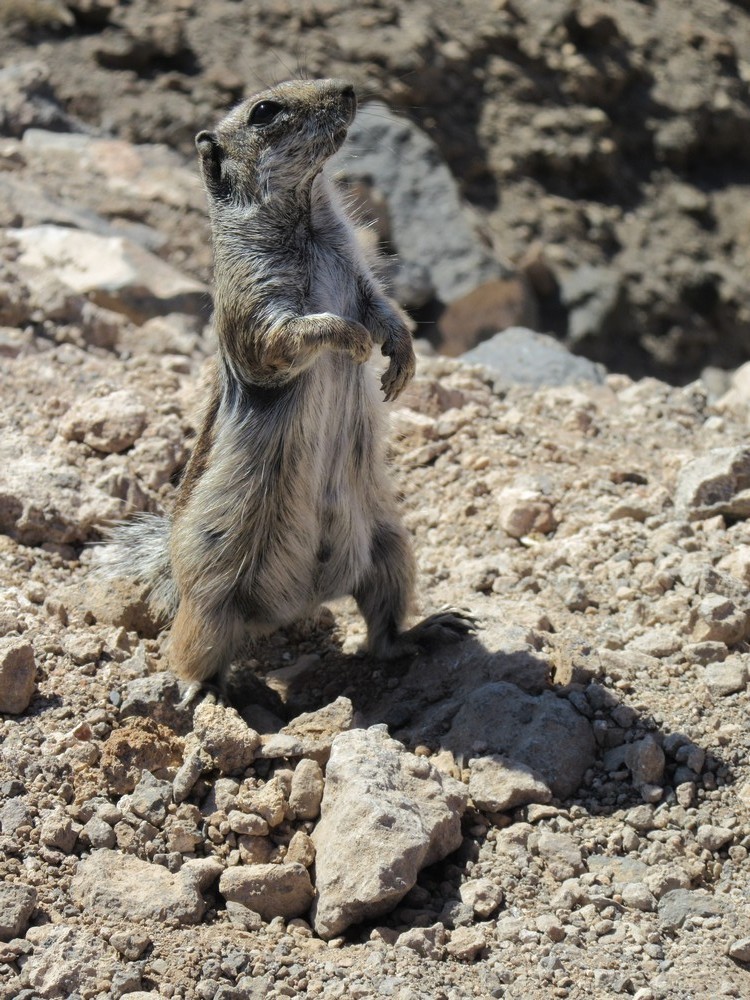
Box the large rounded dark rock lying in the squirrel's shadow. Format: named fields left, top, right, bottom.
left=443, top=681, right=595, bottom=798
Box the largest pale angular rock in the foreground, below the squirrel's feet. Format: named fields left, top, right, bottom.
left=312, top=726, right=466, bottom=938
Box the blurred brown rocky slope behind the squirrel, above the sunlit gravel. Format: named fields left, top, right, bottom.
left=0, top=0, right=750, bottom=387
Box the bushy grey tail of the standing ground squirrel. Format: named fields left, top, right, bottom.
left=96, top=514, right=180, bottom=619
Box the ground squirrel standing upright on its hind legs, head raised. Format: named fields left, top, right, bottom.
left=114, top=80, right=473, bottom=695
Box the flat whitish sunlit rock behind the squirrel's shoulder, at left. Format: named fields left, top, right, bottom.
left=8, top=225, right=208, bottom=322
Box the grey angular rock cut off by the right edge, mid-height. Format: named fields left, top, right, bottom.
left=674, top=446, right=750, bottom=521
